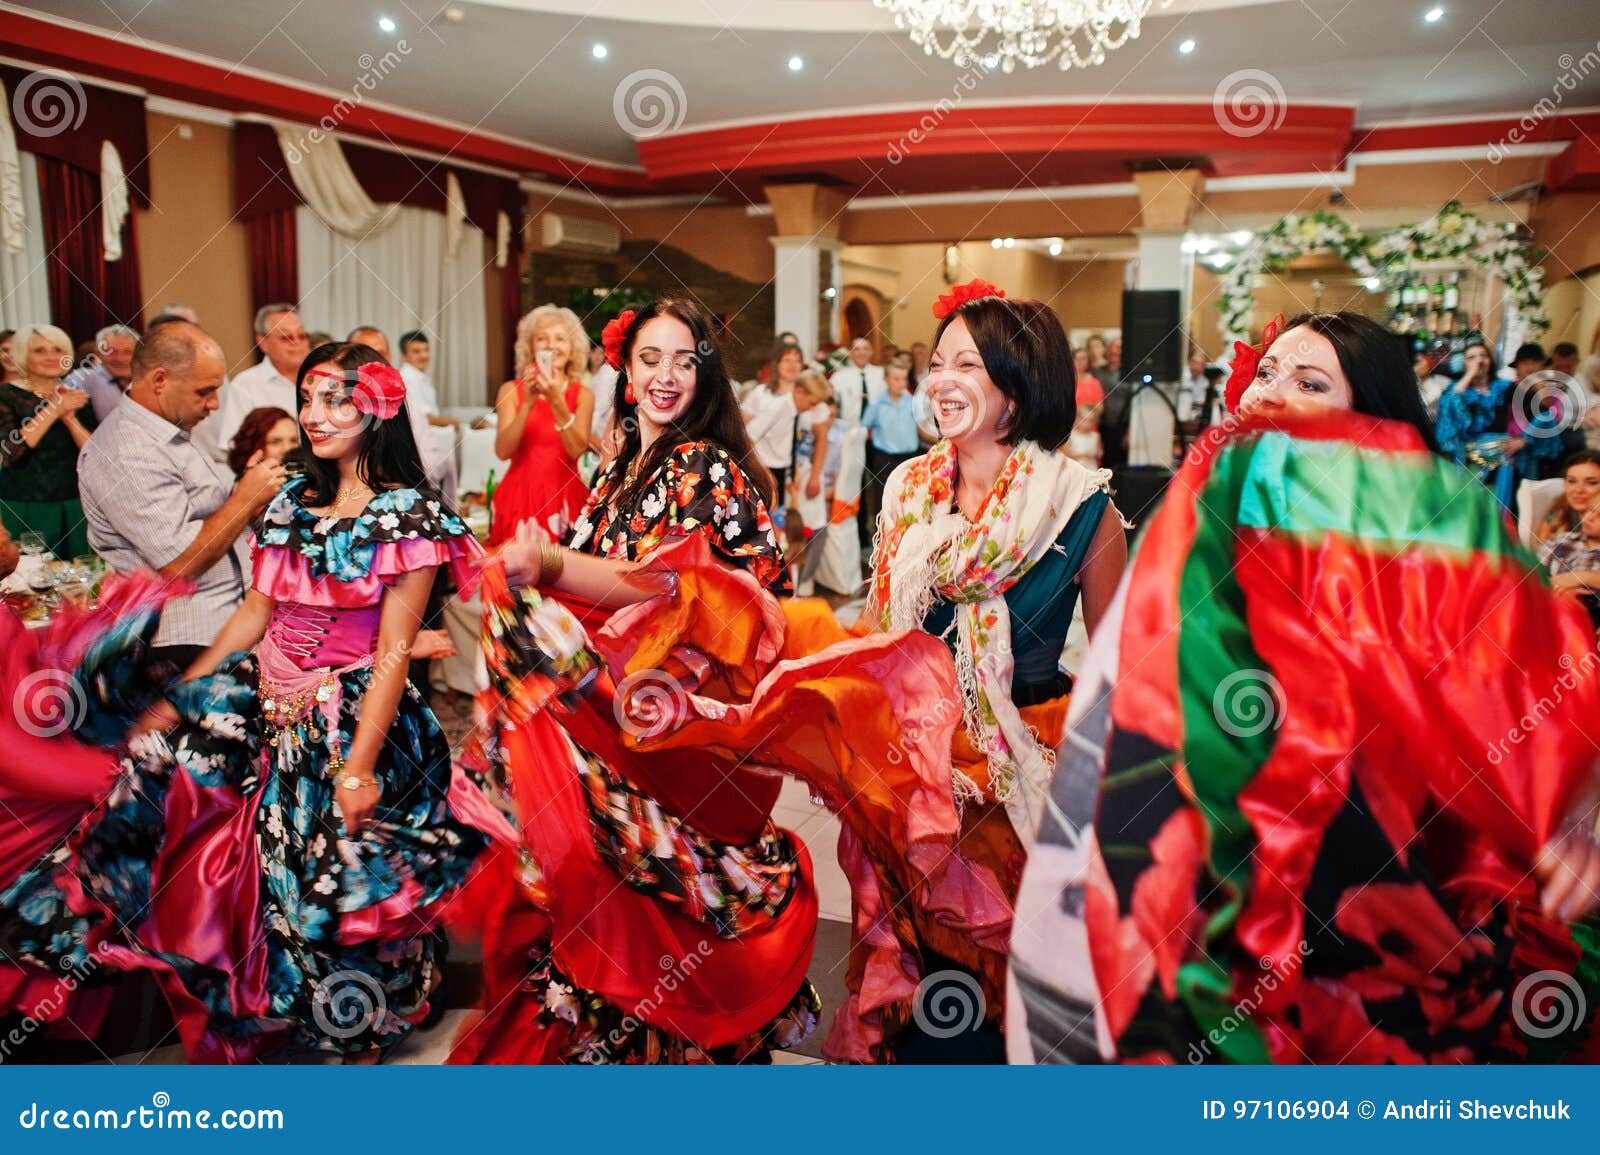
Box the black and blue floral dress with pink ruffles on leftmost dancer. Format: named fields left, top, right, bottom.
left=0, top=478, right=498, bottom=1061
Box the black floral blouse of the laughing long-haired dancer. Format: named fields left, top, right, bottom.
left=566, top=442, right=794, bottom=597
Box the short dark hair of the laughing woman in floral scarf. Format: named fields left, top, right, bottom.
left=933, top=298, right=1078, bottom=450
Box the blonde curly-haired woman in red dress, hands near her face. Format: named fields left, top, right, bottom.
left=490, top=306, right=595, bottom=546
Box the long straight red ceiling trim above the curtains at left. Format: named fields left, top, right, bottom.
left=0, top=13, right=651, bottom=192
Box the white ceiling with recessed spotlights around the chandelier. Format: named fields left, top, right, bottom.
left=12, top=0, right=1600, bottom=163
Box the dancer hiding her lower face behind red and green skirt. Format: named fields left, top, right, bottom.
left=1008, top=314, right=1600, bottom=1064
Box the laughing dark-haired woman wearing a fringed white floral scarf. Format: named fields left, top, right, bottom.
left=832, top=282, right=1126, bottom=1062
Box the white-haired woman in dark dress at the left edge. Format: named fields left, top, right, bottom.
left=0, top=325, right=94, bottom=558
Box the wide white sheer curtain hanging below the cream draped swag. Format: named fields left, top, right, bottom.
left=294, top=205, right=490, bottom=410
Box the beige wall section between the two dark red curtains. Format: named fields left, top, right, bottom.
left=134, top=112, right=254, bottom=371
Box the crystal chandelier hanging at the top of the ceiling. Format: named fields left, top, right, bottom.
left=872, top=0, right=1170, bottom=72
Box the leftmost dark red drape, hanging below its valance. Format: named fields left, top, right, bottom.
left=35, top=154, right=144, bottom=342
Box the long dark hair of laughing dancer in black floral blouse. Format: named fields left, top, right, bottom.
left=611, top=298, right=776, bottom=509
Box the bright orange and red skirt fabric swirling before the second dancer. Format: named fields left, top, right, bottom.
left=451, top=536, right=963, bottom=1062
